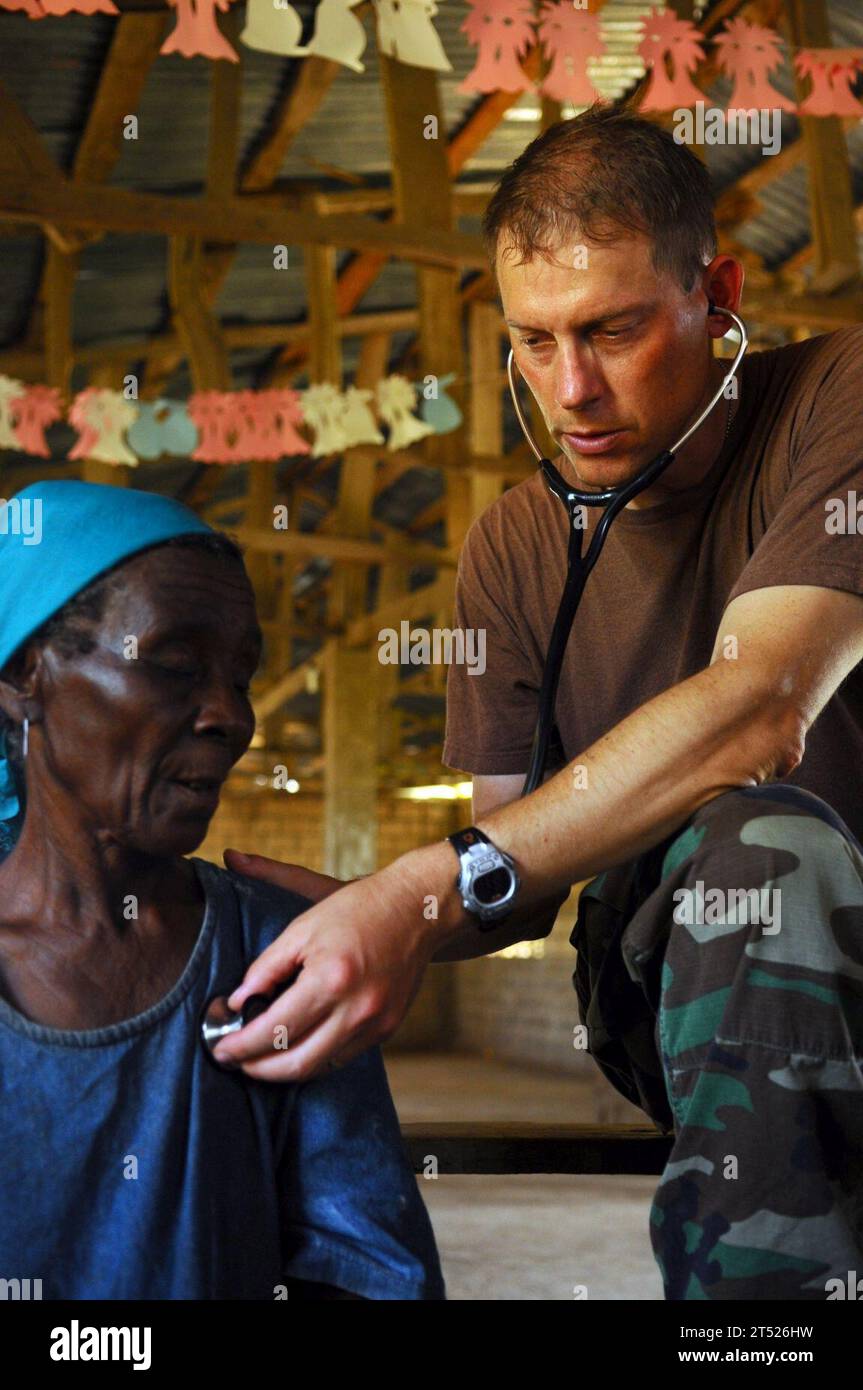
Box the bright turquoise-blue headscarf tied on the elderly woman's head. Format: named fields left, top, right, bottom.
left=0, top=480, right=214, bottom=858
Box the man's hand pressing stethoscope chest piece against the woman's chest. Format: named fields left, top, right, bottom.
left=215, top=842, right=464, bottom=1081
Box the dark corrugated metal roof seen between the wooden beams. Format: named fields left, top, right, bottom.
left=0, top=0, right=863, bottom=494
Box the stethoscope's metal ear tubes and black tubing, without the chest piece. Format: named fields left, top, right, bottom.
left=506, top=309, right=749, bottom=796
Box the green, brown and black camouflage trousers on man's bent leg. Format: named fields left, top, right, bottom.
left=571, top=784, right=863, bottom=1300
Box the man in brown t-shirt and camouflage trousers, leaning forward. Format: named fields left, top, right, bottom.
left=209, top=108, right=863, bottom=1300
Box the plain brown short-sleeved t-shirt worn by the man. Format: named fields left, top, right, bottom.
left=443, top=327, right=863, bottom=841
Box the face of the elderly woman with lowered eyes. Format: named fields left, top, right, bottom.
left=26, top=546, right=261, bottom=856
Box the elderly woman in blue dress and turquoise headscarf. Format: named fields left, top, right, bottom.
left=0, top=482, right=443, bottom=1300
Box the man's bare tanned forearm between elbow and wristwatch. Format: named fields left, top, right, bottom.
left=406, top=660, right=802, bottom=959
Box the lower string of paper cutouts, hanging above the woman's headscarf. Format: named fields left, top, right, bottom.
left=0, top=373, right=463, bottom=467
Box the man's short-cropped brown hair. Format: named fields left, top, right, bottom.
left=482, top=103, right=718, bottom=293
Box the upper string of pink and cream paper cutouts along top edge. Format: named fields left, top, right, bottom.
left=0, top=0, right=863, bottom=118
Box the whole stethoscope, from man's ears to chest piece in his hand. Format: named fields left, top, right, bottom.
left=200, top=302, right=749, bottom=1061
